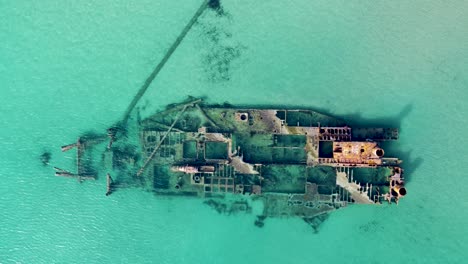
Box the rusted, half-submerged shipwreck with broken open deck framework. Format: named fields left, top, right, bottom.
left=57, top=100, right=406, bottom=228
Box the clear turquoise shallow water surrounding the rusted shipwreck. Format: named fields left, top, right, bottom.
left=0, top=0, right=468, bottom=263
